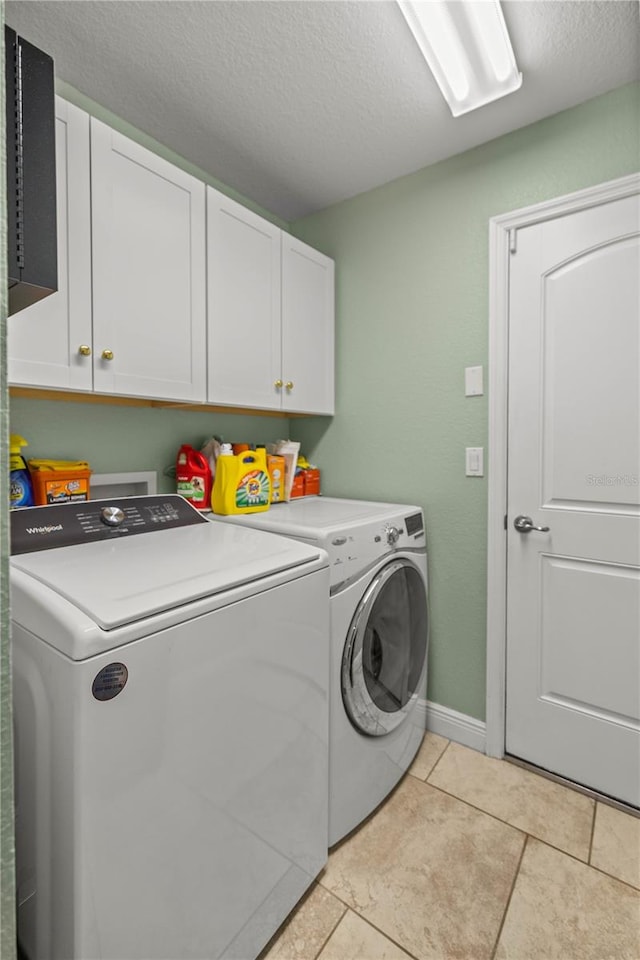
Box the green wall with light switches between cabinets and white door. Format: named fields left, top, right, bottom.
left=292, top=84, right=640, bottom=719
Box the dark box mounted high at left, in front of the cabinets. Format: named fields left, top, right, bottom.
left=4, top=27, right=58, bottom=314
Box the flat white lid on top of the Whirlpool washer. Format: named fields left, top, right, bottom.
left=11, top=523, right=326, bottom=630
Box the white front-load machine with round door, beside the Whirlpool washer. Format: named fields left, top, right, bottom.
left=212, top=497, right=428, bottom=845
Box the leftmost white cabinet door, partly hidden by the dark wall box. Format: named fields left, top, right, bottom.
left=7, top=97, right=92, bottom=390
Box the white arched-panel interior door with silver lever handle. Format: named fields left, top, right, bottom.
left=506, top=195, right=640, bottom=806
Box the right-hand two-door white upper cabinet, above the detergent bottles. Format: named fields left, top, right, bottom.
left=207, top=187, right=334, bottom=414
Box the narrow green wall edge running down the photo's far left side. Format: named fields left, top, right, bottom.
left=0, top=0, right=16, bottom=960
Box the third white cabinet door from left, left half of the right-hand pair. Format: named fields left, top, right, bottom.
left=207, top=187, right=283, bottom=410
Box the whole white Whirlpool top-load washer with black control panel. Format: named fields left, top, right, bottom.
left=11, top=496, right=329, bottom=960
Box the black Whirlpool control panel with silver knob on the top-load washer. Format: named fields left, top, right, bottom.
left=11, top=494, right=207, bottom=556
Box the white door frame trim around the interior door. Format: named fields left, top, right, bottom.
left=485, top=173, right=640, bottom=758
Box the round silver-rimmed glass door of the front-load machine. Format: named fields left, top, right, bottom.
left=342, top=559, right=428, bottom=737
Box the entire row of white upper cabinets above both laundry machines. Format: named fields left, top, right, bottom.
left=8, top=98, right=334, bottom=414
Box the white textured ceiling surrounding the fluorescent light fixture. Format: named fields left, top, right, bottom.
left=5, top=0, right=640, bottom=220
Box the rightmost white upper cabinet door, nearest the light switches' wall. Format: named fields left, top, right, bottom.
left=282, top=233, right=335, bottom=414
